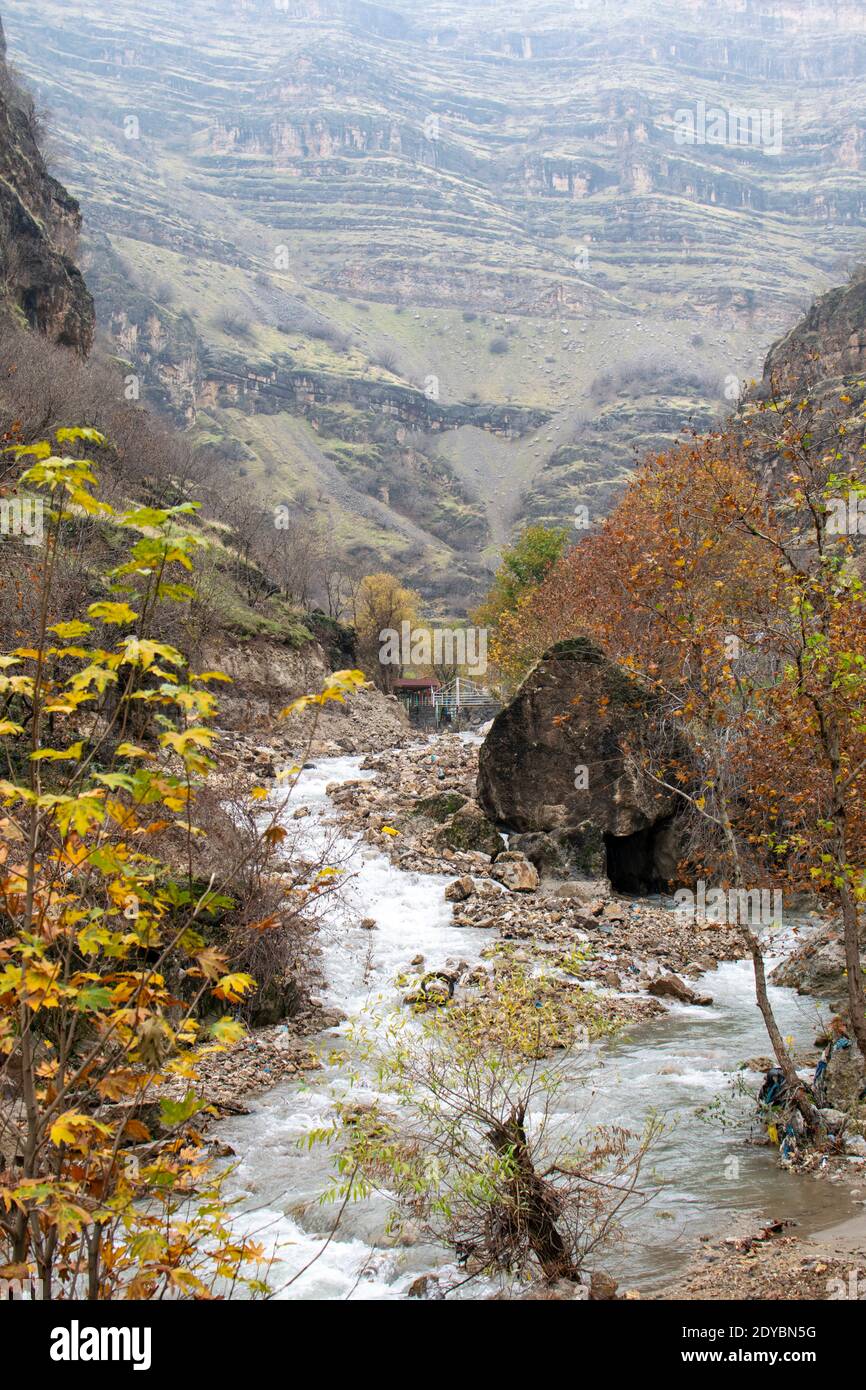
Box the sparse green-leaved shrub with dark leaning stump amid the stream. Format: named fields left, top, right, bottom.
left=325, top=965, right=662, bottom=1284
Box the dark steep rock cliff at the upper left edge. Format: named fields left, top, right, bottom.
left=0, top=22, right=95, bottom=354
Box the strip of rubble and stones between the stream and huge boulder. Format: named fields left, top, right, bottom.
left=332, top=734, right=744, bottom=1020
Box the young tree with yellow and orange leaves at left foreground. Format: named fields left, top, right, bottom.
left=0, top=430, right=363, bottom=1300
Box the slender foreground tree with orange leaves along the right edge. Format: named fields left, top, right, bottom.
left=722, top=381, right=866, bottom=1059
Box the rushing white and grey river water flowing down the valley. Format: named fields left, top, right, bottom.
left=220, top=758, right=851, bottom=1300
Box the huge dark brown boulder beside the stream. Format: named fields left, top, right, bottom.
left=478, top=638, right=685, bottom=892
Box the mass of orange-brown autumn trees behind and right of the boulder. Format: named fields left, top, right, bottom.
left=495, top=396, right=866, bottom=1081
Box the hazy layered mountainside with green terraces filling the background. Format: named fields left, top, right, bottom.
left=7, top=0, right=866, bottom=612
